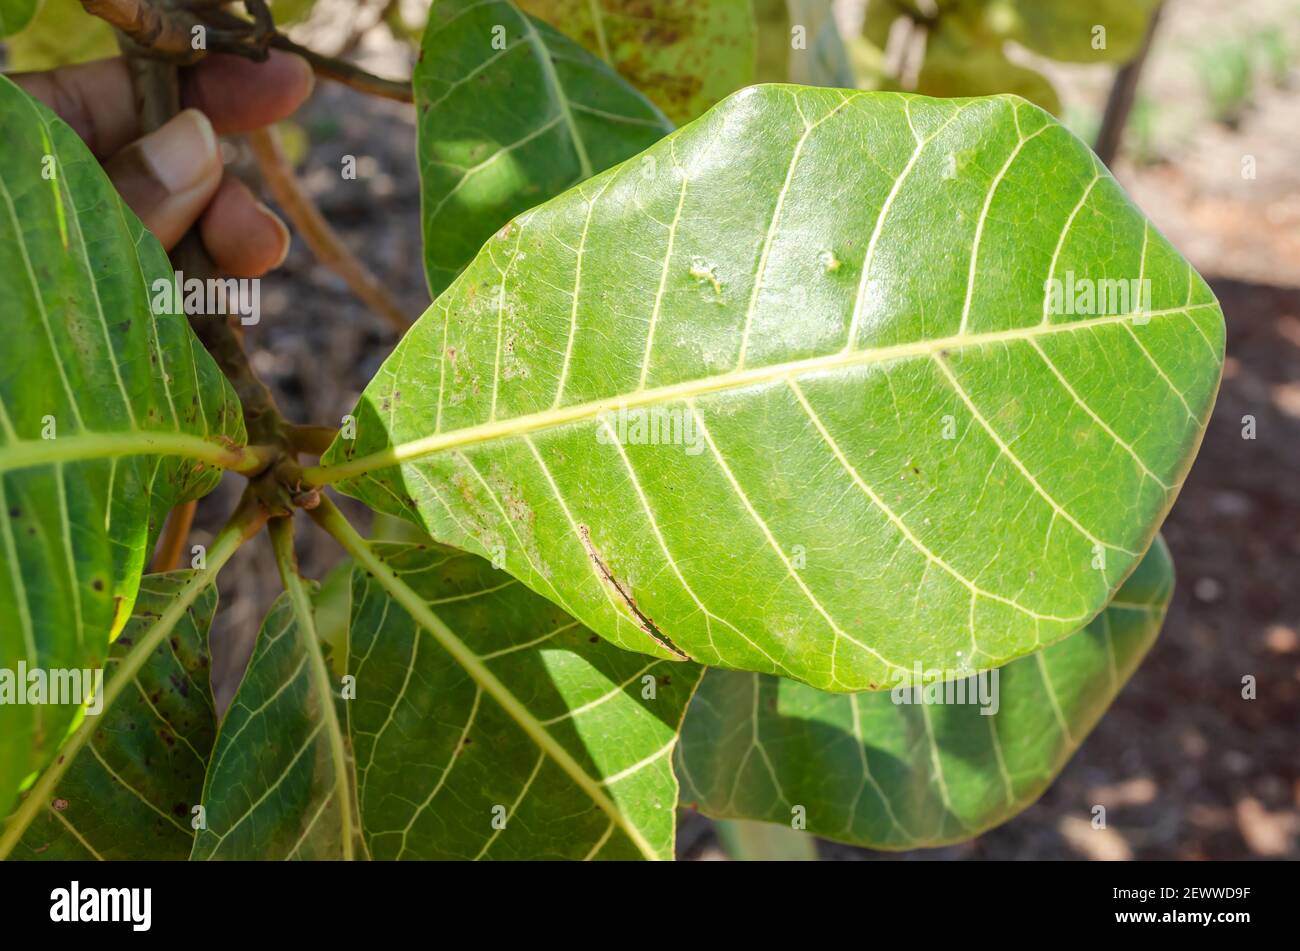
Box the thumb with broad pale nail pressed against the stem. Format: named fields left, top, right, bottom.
left=104, top=109, right=221, bottom=249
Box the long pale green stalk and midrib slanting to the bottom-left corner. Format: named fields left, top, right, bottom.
left=0, top=494, right=267, bottom=860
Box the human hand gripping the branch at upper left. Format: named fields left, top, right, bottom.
left=10, top=51, right=313, bottom=277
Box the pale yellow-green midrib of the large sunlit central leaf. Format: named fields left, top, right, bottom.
left=312, top=301, right=1218, bottom=485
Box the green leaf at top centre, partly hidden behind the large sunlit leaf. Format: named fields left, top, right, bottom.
left=415, top=0, right=672, bottom=296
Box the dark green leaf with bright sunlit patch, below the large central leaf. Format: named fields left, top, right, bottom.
left=348, top=544, right=703, bottom=859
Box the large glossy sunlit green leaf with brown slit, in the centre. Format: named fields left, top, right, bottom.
left=319, top=86, right=1223, bottom=691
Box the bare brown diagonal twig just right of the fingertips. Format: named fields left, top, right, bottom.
left=247, top=129, right=411, bottom=334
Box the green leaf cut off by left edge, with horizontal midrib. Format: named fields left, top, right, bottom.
left=0, top=78, right=248, bottom=813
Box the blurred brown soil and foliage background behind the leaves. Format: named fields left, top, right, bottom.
left=4, top=0, right=1300, bottom=860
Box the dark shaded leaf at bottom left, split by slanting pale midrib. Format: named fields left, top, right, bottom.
left=12, top=572, right=217, bottom=860
